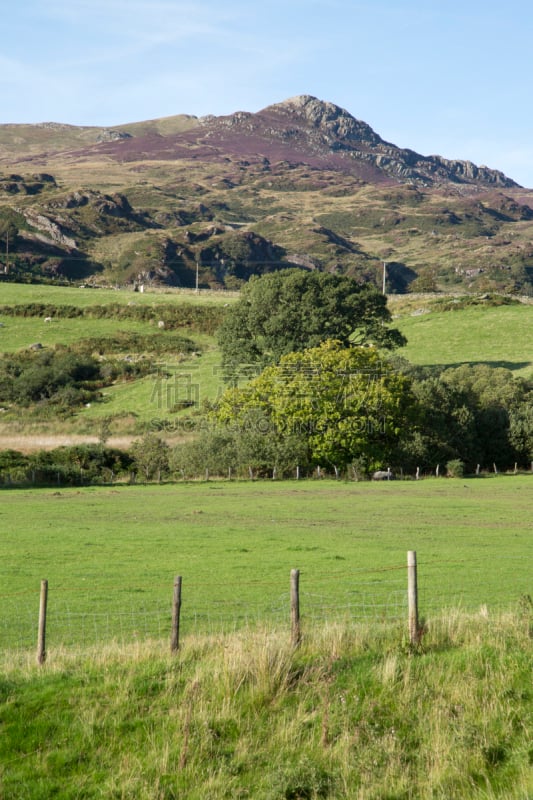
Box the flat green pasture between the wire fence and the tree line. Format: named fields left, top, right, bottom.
left=0, top=475, right=533, bottom=649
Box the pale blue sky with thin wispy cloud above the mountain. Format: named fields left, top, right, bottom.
left=4, top=0, right=533, bottom=188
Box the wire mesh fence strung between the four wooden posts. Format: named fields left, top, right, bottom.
left=0, top=562, right=521, bottom=651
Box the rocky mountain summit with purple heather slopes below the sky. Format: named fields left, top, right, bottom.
left=41, top=95, right=519, bottom=188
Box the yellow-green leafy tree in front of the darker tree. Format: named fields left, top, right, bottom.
left=216, top=340, right=412, bottom=468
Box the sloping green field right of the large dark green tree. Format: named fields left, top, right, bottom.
left=392, top=300, right=533, bottom=375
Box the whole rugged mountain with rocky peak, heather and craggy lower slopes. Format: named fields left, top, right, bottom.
left=0, top=95, right=533, bottom=294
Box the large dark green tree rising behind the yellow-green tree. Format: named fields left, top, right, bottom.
left=218, top=269, right=405, bottom=380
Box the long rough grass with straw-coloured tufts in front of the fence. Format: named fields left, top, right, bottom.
left=0, top=608, right=533, bottom=800
